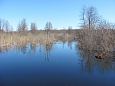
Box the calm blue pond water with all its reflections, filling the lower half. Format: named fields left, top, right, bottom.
left=0, top=42, right=115, bottom=86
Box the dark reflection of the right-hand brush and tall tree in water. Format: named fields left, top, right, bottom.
left=77, top=46, right=115, bottom=72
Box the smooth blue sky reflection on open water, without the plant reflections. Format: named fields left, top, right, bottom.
left=0, top=42, right=115, bottom=86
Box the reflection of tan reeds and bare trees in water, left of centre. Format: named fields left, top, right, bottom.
left=15, top=43, right=54, bottom=62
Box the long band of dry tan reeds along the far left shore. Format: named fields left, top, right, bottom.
left=0, top=30, right=75, bottom=47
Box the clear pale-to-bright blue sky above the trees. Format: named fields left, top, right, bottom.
left=0, top=0, right=115, bottom=29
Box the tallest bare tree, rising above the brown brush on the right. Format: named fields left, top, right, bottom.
left=82, top=7, right=99, bottom=29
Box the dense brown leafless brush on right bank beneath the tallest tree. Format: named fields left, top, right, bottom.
left=77, top=29, right=115, bottom=52
